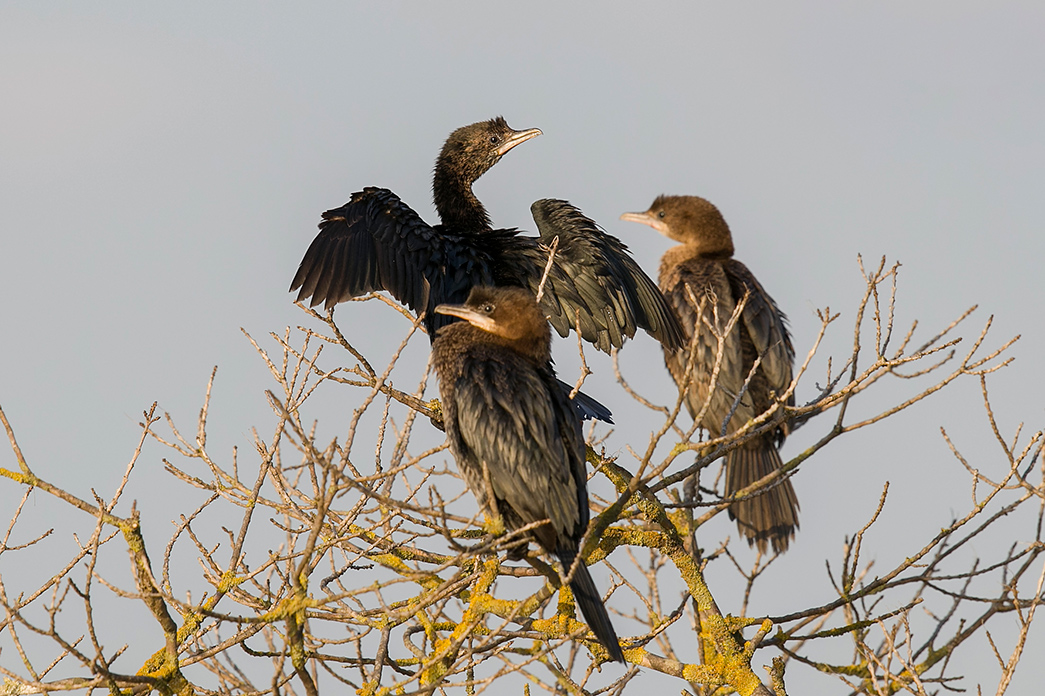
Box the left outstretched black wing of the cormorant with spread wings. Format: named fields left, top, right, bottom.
left=291, top=187, right=443, bottom=312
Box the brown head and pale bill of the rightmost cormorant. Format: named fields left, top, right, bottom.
left=621, top=195, right=734, bottom=256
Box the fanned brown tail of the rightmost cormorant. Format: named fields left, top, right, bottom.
left=725, top=440, right=798, bottom=554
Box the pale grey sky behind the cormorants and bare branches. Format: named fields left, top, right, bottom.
left=0, top=2, right=1045, bottom=693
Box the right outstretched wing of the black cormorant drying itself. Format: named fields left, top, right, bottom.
left=521, top=199, right=684, bottom=352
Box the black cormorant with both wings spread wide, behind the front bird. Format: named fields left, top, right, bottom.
left=291, top=117, right=682, bottom=352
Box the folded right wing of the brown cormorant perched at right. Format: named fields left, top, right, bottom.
left=726, top=259, right=794, bottom=403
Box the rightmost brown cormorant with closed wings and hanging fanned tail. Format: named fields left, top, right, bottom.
left=621, top=195, right=798, bottom=553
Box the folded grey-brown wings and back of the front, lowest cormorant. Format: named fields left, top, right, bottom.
left=452, top=359, right=587, bottom=551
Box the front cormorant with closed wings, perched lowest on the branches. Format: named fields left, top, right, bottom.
left=432, top=286, right=624, bottom=663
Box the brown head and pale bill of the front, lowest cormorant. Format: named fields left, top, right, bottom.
left=436, top=286, right=552, bottom=362
